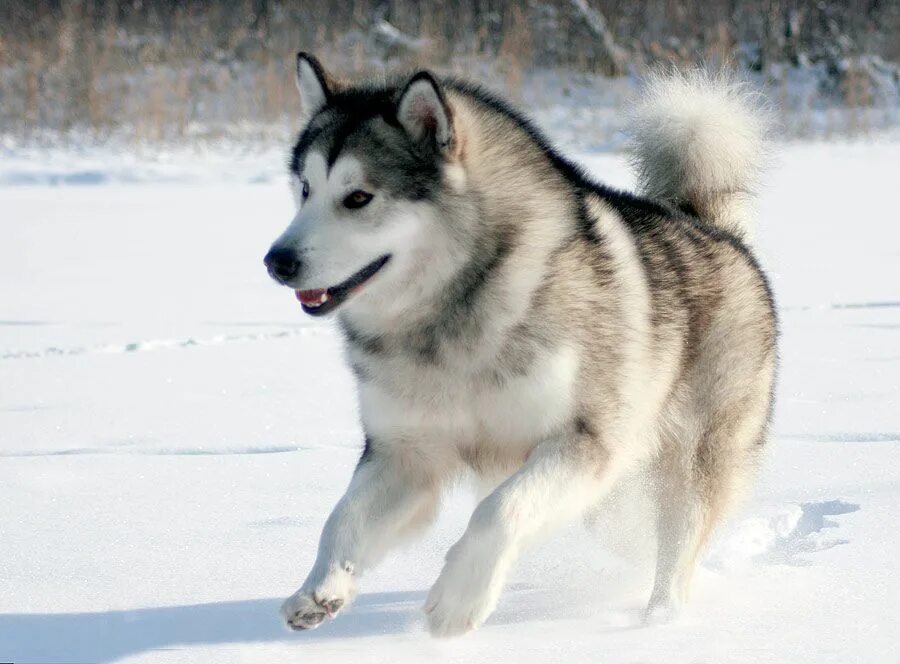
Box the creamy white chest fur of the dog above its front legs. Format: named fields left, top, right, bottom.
left=360, top=348, right=579, bottom=469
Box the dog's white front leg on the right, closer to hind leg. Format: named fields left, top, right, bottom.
left=425, top=424, right=620, bottom=636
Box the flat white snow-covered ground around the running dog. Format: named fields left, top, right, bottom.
left=0, top=143, right=900, bottom=664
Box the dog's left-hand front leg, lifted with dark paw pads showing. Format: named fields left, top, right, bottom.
left=281, top=446, right=441, bottom=629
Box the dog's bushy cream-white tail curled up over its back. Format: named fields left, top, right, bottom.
left=631, top=70, right=769, bottom=238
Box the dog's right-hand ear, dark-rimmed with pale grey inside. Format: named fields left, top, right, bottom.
left=397, top=71, right=454, bottom=154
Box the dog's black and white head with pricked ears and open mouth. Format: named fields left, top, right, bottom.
left=265, top=54, right=455, bottom=315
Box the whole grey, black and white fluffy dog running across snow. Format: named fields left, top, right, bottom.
left=265, top=53, right=776, bottom=636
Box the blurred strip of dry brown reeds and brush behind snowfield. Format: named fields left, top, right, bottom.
left=0, top=0, right=900, bottom=149
